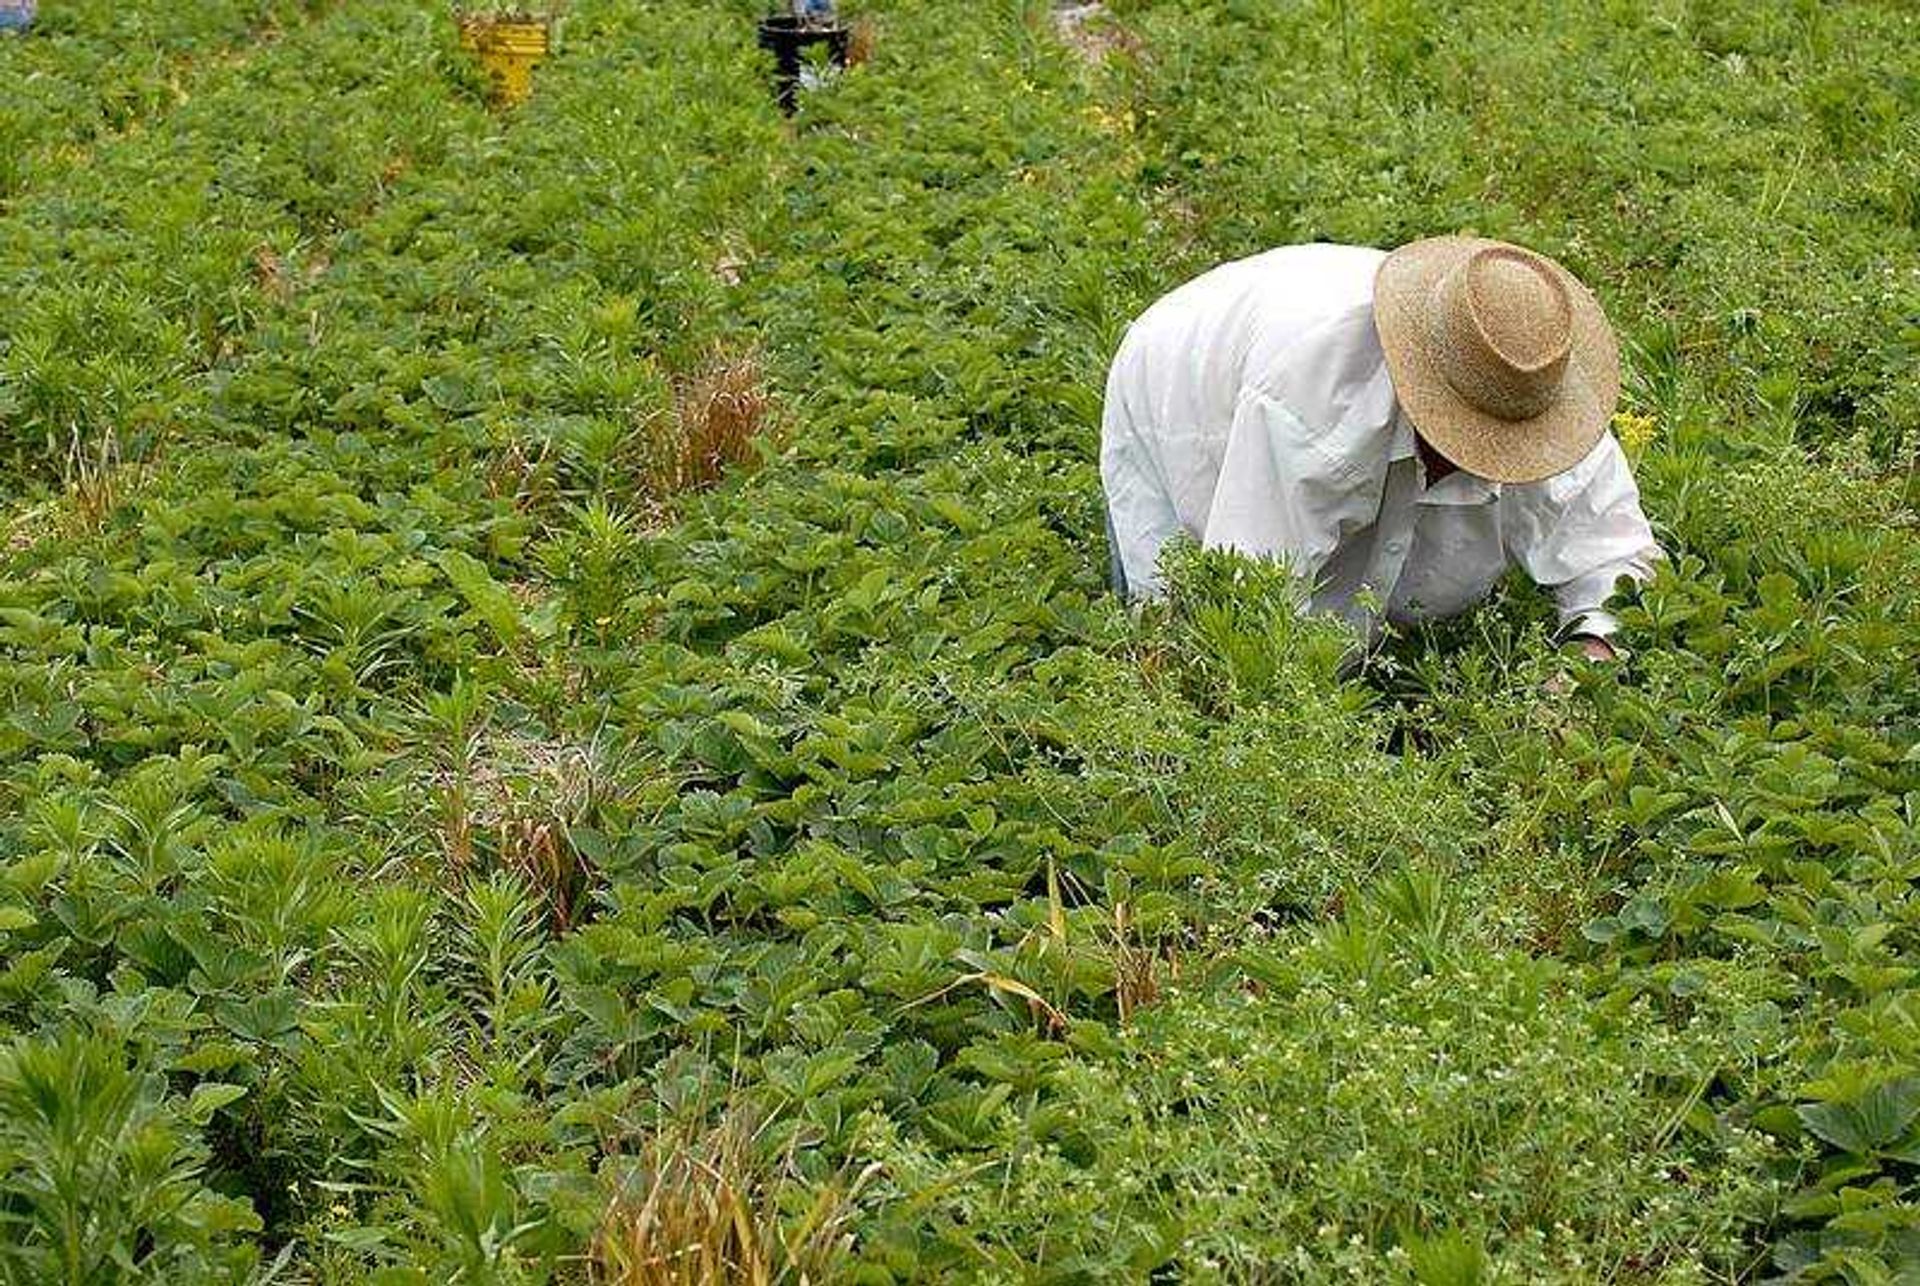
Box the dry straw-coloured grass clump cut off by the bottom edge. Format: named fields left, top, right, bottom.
left=588, top=1107, right=877, bottom=1286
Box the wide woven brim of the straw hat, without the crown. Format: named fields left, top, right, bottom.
left=1373, top=236, right=1620, bottom=482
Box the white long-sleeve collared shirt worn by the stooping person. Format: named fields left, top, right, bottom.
left=1100, top=246, right=1659, bottom=639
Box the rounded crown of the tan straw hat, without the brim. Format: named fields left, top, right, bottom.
left=1432, top=246, right=1572, bottom=420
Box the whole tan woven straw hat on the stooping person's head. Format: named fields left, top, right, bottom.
left=1373, top=236, right=1620, bottom=482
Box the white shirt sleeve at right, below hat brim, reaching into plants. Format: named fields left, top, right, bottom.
left=1501, top=434, right=1663, bottom=637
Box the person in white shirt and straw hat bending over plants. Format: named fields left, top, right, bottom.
left=1100, top=236, right=1659, bottom=658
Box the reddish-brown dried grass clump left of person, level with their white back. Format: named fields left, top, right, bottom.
left=647, top=353, right=774, bottom=499
